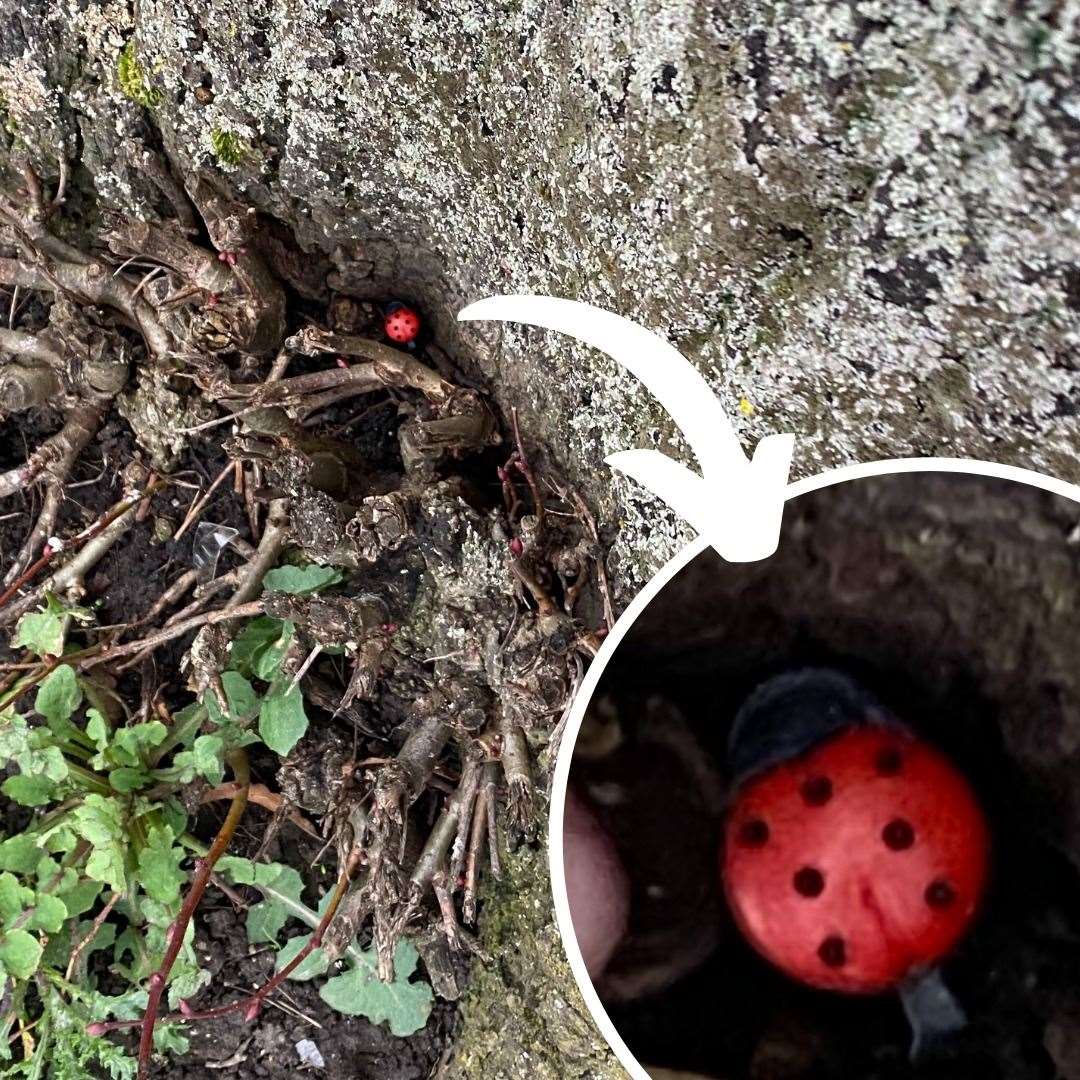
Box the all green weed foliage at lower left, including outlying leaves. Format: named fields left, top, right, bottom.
left=0, top=566, right=432, bottom=1080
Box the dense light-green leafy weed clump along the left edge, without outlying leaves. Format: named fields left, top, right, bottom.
left=0, top=597, right=237, bottom=1077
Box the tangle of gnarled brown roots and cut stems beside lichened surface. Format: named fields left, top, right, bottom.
left=0, top=143, right=613, bottom=1071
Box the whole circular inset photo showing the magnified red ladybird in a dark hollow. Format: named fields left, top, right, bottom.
left=555, top=472, right=1080, bottom=1080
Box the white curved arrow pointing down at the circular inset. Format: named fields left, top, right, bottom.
left=458, top=295, right=795, bottom=563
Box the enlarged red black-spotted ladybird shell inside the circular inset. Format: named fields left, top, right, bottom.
left=724, top=727, right=989, bottom=994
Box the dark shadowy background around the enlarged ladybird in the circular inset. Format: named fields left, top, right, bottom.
left=572, top=475, right=1080, bottom=1080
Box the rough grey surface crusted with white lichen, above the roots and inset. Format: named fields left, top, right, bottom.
left=0, top=0, right=1080, bottom=595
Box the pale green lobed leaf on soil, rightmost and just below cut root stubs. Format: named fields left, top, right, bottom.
left=319, top=939, right=434, bottom=1036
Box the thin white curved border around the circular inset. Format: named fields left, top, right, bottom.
left=548, top=458, right=1080, bottom=1080
